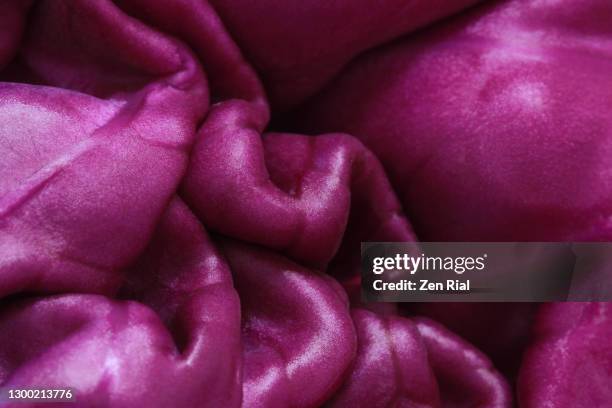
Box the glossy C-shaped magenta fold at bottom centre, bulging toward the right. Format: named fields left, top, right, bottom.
left=222, top=241, right=356, bottom=407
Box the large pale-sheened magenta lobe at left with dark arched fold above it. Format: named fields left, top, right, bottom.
left=0, top=1, right=207, bottom=296
